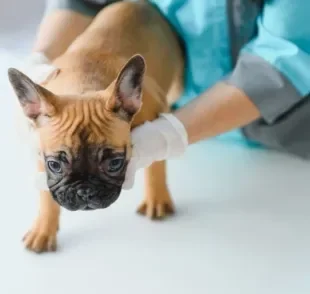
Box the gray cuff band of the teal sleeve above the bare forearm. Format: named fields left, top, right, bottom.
left=227, top=54, right=303, bottom=124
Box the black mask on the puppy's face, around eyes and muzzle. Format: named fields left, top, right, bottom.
left=45, top=143, right=128, bottom=210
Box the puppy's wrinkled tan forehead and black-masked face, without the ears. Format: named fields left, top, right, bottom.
left=35, top=96, right=131, bottom=210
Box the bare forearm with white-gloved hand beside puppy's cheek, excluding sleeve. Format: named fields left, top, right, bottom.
left=123, top=82, right=260, bottom=189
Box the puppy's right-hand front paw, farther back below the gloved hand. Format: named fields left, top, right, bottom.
left=137, top=191, right=175, bottom=219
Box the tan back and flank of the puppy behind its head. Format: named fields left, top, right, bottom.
left=48, top=1, right=184, bottom=124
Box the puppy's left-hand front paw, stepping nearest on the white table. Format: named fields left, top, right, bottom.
left=23, top=218, right=58, bottom=253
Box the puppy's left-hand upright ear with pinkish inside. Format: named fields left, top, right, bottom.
left=8, top=68, right=56, bottom=120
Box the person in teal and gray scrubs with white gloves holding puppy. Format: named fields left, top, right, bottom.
left=25, top=0, right=310, bottom=186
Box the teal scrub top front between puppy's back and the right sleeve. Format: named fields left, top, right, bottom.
left=149, top=0, right=259, bottom=107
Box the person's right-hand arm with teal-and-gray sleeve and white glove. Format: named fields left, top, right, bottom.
left=124, top=0, right=310, bottom=188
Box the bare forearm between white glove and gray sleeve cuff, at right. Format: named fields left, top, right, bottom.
left=174, top=82, right=260, bottom=144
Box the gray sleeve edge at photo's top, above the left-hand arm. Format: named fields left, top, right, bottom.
left=45, top=0, right=121, bottom=17
